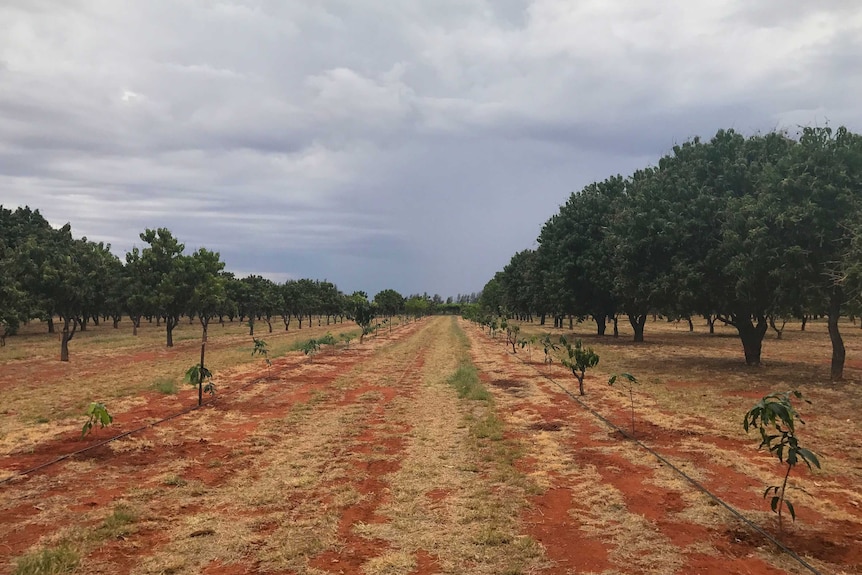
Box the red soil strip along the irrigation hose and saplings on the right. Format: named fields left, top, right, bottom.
left=465, top=324, right=862, bottom=575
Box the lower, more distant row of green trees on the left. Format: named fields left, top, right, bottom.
left=0, top=206, right=442, bottom=361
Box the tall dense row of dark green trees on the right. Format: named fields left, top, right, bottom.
left=480, top=127, right=862, bottom=380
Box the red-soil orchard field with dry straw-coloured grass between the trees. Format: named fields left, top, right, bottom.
left=0, top=317, right=862, bottom=575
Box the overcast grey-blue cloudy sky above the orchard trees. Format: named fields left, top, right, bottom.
left=0, top=0, right=862, bottom=297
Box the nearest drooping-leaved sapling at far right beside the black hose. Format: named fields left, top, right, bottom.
left=742, top=391, right=820, bottom=528
